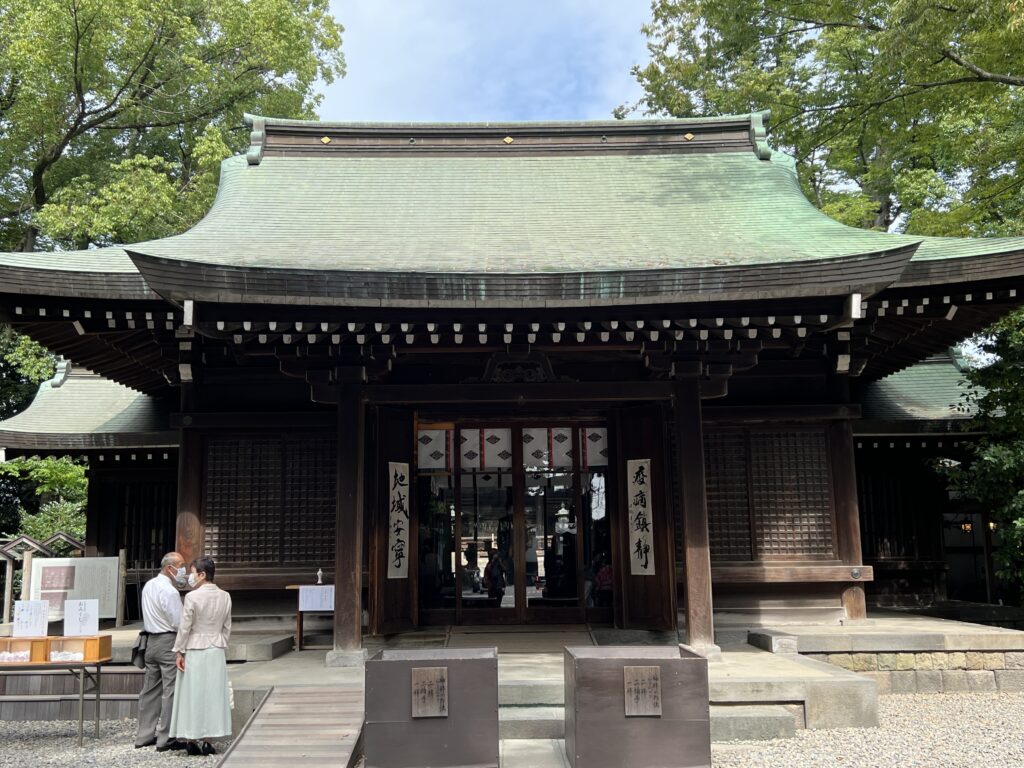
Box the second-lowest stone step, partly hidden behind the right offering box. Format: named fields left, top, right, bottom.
left=498, top=705, right=797, bottom=741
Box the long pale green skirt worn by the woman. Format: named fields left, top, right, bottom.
left=171, top=648, right=231, bottom=740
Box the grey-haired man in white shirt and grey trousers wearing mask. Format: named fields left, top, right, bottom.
left=135, top=552, right=186, bottom=752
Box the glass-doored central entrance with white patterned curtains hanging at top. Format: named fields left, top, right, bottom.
left=414, top=422, right=614, bottom=625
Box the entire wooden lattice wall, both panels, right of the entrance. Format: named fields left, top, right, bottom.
left=705, top=427, right=836, bottom=562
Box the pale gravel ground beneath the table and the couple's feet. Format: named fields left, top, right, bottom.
left=0, top=720, right=229, bottom=768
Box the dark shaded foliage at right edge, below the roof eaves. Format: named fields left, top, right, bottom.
left=946, top=310, right=1024, bottom=587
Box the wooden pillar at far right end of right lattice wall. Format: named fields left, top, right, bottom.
left=828, top=421, right=867, bottom=618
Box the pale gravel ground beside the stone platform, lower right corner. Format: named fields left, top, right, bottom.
left=712, top=693, right=1024, bottom=768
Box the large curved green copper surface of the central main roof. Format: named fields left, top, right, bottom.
left=130, top=152, right=919, bottom=273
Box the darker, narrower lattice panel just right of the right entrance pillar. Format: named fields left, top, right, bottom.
left=705, top=429, right=752, bottom=560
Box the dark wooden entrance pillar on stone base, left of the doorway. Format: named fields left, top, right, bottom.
left=328, top=384, right=366, bottom=665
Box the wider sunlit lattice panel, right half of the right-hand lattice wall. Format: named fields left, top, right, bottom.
left=750, top=429, right=835, bottom=559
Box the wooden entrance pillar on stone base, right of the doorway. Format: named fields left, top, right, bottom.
left=673, top=379, right=715, bottom=648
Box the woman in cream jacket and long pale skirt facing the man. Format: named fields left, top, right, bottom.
left=171, top=557, right=231, bottom=755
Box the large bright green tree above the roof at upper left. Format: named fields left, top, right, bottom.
left=0, top=0, right=344, bottom=251
